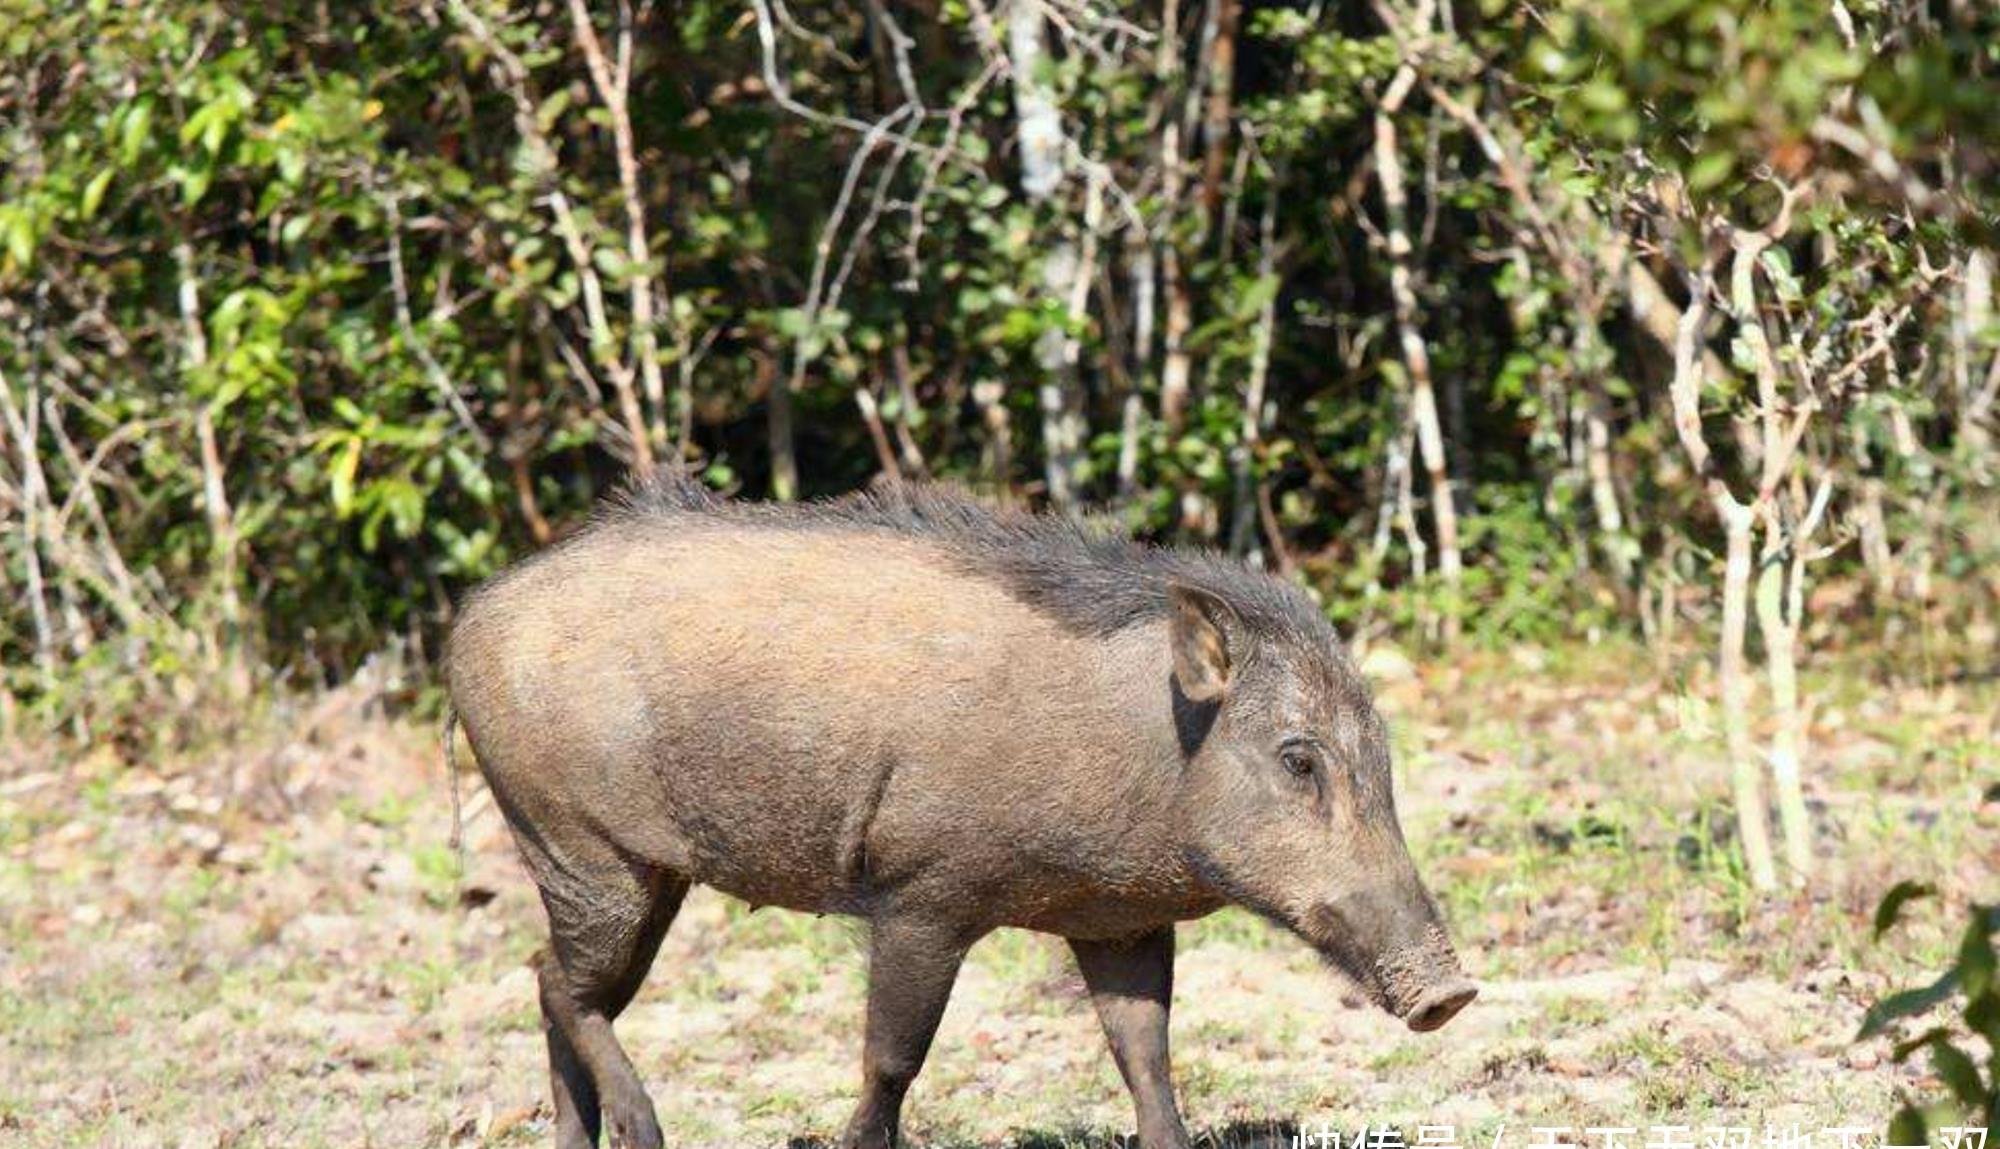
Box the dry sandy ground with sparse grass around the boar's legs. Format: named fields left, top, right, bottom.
left=0, top=651, right=2000, bottom=1149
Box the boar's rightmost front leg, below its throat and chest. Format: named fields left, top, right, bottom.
left=1070, top=925, right=1188, bottom=1149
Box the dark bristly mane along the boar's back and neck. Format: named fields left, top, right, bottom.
left=590, top=464, right=1338, bottom=649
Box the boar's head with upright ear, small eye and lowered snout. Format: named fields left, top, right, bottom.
left=1168, top=583, right=1478, bottom=1031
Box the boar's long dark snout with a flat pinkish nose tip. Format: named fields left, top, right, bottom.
left=1310, top=895, right=1480, bottom=1033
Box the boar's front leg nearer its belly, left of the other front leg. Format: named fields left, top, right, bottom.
left=840, top=911, right=978, bottom=1149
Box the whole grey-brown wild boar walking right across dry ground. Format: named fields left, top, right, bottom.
left=448, top=470, right=1476, bottom=1149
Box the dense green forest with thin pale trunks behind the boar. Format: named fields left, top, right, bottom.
left=0, top=0, right=2000, bottom=1144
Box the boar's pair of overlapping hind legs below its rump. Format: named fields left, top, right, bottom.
left=538, top=859, right=688, bottom=1149
